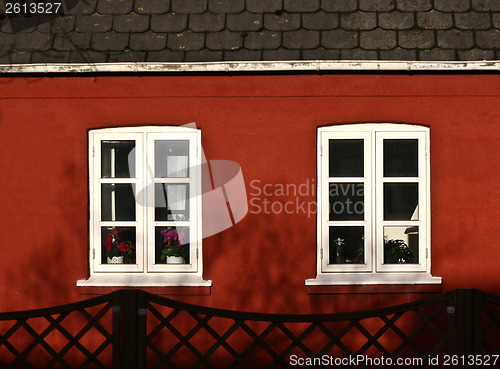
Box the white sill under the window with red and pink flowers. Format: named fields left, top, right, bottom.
left=76, top=273, right=212, bottom=287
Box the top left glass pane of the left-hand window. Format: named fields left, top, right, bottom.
left=101, top=140, right=135, bottom=178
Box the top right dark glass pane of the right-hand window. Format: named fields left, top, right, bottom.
left=384, top=139, right=418, bottom=177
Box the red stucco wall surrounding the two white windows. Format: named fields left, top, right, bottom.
left=0, top=75, right=500, bottom=313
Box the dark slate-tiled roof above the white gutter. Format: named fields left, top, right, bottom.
left=0, top=0, right=500, bottom=64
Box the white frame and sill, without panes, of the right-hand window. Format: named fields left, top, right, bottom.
left=306, top=123, right=441, bottom=285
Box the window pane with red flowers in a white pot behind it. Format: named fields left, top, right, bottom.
left=101, top=227, right=136, bottom=264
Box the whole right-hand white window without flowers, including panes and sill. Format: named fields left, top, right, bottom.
left=306, top=124, right=441, bottom=285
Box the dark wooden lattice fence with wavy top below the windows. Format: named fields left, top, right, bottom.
left=0, top=289, right=500, bottom=369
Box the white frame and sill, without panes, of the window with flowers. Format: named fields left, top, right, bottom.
left=77, top=126, right=212, bottom=286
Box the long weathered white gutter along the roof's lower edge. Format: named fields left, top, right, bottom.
left=0, top=60, right=500, bottom=74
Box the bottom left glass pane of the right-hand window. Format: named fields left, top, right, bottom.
left=328, top=226, right=365, bottom=264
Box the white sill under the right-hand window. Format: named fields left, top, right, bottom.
left=306, top=273, right=442, bottom=286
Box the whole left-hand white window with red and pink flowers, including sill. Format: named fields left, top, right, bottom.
left=78, top=127, right=211, bottom=286
